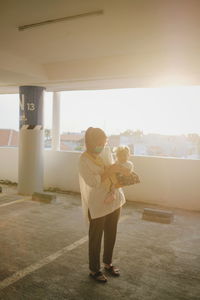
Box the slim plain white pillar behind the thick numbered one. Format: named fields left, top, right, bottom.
left=52, top=92, right=60, bottom=151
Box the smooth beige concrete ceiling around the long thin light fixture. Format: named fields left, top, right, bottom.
left=0, top=0, right=200, bottom=93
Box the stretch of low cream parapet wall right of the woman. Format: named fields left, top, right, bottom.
left=124, top=156, right=200, bottom=210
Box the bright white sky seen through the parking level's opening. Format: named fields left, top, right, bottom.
left=0, top=86, right=200, bottom=135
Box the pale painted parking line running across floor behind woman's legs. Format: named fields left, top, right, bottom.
left=0, top=215, right=130, bottom=290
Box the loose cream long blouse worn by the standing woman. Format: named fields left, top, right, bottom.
left=79, top=153, right=125, bottom=219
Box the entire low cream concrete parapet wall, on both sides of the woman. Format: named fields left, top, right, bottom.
left=0, top=148, right=200, bottom=210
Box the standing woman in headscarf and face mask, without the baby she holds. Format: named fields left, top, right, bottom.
left=79, top=127, right=127, bottom=283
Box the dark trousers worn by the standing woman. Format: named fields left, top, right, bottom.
left=88, top=208, right=120, bottom=272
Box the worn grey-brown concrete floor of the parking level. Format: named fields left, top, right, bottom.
left=0, top=185, right=200, bottom=300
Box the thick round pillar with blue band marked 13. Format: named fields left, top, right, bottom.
left=18, top=86, right=45, bottom=195
